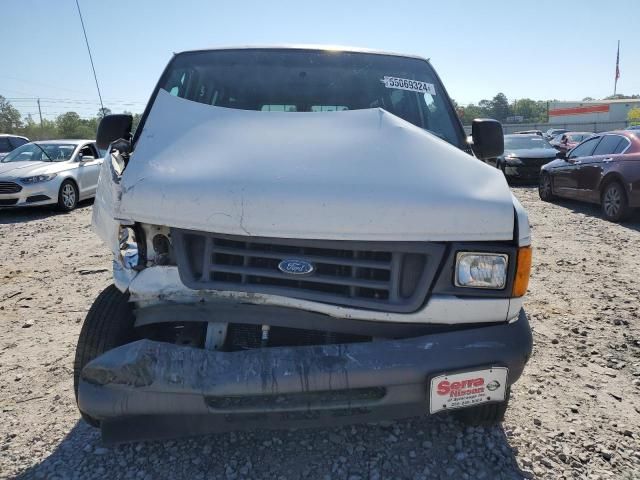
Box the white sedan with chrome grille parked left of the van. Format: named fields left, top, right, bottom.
left=0, top=140, right=102, bottom=211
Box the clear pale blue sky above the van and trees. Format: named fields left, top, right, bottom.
left=0, top=0, right=640, bottom=118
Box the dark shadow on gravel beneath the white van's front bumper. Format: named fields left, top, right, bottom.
left=16, top=416, right=532, bottom=480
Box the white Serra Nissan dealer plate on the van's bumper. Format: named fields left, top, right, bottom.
left=429, top=367, right=509, bottom=413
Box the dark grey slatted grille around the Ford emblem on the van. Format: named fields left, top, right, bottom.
left=171, top=229, right=444, bottom=312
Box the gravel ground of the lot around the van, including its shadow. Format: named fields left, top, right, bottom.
left=0, top=187, right=640, bottom=480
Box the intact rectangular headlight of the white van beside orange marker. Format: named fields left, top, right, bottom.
left=455, top=252, right=509, bottom=290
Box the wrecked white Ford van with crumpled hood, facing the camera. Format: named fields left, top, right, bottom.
left=74, top=47, right=532, bottom=441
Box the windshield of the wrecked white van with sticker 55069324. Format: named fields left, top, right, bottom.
left=155, top=49, right=464, bottom=147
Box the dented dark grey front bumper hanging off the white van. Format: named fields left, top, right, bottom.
left=78, top=311, right=532, bottom=442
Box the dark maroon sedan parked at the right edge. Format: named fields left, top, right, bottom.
left=539, top=130, right=640, bottom=222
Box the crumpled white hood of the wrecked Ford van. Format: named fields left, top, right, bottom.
left=115, top=90, right=514, bottom=241
